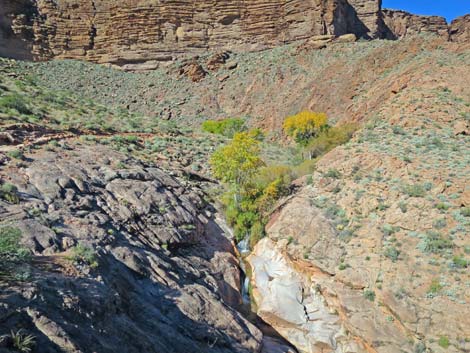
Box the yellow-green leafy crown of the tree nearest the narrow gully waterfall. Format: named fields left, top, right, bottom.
left=210, top=132, right=264, bottom=186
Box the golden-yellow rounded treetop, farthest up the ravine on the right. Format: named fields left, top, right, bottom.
left=283, top=111, right=328, bottom=144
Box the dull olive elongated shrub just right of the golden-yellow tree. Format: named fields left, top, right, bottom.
left=304, top=124, right=357, bottom=159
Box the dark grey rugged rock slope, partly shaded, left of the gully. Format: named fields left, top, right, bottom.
left=0, top=144, right=270, bottom=352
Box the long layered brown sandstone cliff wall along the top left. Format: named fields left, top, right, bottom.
left=2, top=0, right=380, bottom=64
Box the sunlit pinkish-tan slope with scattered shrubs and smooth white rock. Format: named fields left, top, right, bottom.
left=249, top=37, right=470, bottom=353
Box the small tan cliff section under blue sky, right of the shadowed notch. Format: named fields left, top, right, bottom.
left=382, top=9, right=449, bottom=39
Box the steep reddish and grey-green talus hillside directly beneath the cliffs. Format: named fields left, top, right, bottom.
left=21, top=36, right=468, bottom=132
